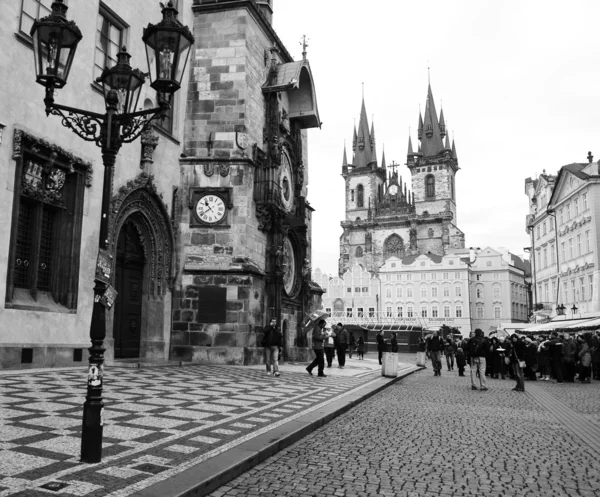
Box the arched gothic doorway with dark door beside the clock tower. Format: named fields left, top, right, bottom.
left=106, top=173, right=175, bottom=359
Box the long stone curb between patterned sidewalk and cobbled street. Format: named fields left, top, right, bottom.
left=133, top=366, right=424, bottom=497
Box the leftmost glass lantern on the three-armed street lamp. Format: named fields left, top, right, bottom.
left=30, top=0, right=82, bottom=88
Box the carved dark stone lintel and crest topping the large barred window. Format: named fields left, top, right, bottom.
left=12, top=128, right=94, bottom=188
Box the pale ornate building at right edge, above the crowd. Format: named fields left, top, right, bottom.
left=525, top=154, right=600, bottom=318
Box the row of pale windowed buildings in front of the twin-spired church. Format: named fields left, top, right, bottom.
left=315, top=247, right=529, bottom=333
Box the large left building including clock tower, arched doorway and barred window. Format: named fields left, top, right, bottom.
left=0, top=0, right=320, bottom=368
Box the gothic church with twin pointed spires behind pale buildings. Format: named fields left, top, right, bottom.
left=338, top=85, right=465, bottom=275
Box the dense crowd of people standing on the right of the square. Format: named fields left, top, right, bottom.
left=419, top=329, right=600, bottom=392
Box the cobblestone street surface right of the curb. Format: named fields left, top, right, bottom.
left=210, top=369, right=600, bottom=497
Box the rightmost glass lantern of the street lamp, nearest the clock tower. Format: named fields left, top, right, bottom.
left=142, top=1, right=194, bottom=94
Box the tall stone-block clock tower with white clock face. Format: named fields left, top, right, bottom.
left=171, top=0, right=320, bottom=364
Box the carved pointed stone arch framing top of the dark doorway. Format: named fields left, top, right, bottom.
left=108, top=173, right=175, bottom=295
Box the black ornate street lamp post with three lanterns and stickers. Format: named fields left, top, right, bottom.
left=31, top=0, right=194, bottom=463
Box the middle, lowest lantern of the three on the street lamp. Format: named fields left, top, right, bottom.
left=96, top=47, right=146, bottom=114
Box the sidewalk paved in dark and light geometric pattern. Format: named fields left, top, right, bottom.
left=0, top=365, right=390, bottom=497
